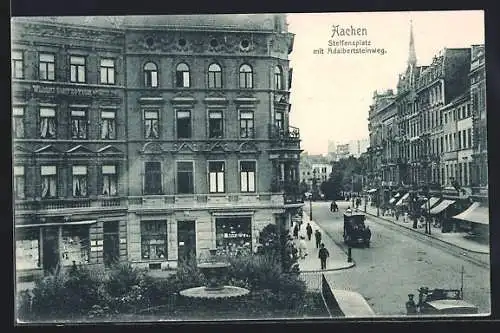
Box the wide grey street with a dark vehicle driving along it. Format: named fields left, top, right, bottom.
left=304, top=201, right=491, bottom=316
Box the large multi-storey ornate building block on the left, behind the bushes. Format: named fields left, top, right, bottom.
left=12, top=14, right=302, bottom=275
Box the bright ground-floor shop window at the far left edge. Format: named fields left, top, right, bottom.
left=16, top=228, right=41, bottom=270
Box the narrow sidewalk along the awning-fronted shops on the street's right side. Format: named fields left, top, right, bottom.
left=359, top=203, right=490, bottom=254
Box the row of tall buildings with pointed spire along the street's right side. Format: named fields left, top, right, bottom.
left=366, top=21, right=488, bottom=223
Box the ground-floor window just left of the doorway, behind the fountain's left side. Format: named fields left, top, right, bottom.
left=141, top=221, right=167, bottom=260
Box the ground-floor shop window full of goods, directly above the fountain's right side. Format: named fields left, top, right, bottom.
left=215, top=217, right=252, bottom=255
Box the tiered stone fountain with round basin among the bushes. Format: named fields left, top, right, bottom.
left=180, top=249, right=250, bottom=299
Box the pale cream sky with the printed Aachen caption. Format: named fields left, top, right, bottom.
left=287, top=10, right=488, bottom=154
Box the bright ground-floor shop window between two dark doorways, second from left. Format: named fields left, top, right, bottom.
left=61, top=226, right=90, bottom=266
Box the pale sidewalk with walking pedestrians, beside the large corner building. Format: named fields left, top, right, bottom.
left=290, top=214, right=354, bottom=272
